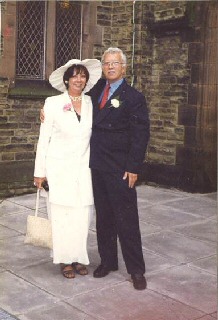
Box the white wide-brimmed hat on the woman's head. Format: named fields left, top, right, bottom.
left=49, top=59, right=102, bottom=92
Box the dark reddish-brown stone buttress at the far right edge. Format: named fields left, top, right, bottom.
left=177, top=1, right=218, bottom=192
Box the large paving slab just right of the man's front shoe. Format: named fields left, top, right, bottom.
left=150, top=266, right=217, bottom=313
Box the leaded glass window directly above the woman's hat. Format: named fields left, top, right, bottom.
left=55, top=1, right=81, bottom=67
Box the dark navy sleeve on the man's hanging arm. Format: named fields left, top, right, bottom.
left=126, top=93, right=150, bottom=173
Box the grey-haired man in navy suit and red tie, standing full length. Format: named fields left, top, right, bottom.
left=88, top=48, right=149, bottom=290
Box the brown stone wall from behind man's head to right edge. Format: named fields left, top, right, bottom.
left=94, top=1, right=218, bottom=192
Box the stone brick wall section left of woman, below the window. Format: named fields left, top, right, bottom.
left=0, top=79, right=43, bottom=198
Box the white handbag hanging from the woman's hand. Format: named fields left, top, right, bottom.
left=24, top=189, right=52, bottom=249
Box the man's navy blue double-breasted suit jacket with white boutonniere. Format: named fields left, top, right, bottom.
left=88, top=79, right=149, bottom=173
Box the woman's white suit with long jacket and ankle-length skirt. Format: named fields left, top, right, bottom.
left=34, top=92, right=93, bottom=264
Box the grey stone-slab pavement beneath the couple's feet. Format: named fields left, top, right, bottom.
left=0, top=185, right=217, bottom=320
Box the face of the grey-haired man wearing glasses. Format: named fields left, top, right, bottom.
left=102, top=52, right=126, bottom=83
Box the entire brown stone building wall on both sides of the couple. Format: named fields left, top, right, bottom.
left=0, top=1, right=218, bottom=197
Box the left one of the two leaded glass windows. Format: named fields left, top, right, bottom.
left=16, top=1, right=46, bottom=79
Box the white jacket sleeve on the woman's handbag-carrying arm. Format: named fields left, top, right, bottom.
left=34, top=98, right=54, bottom=178
